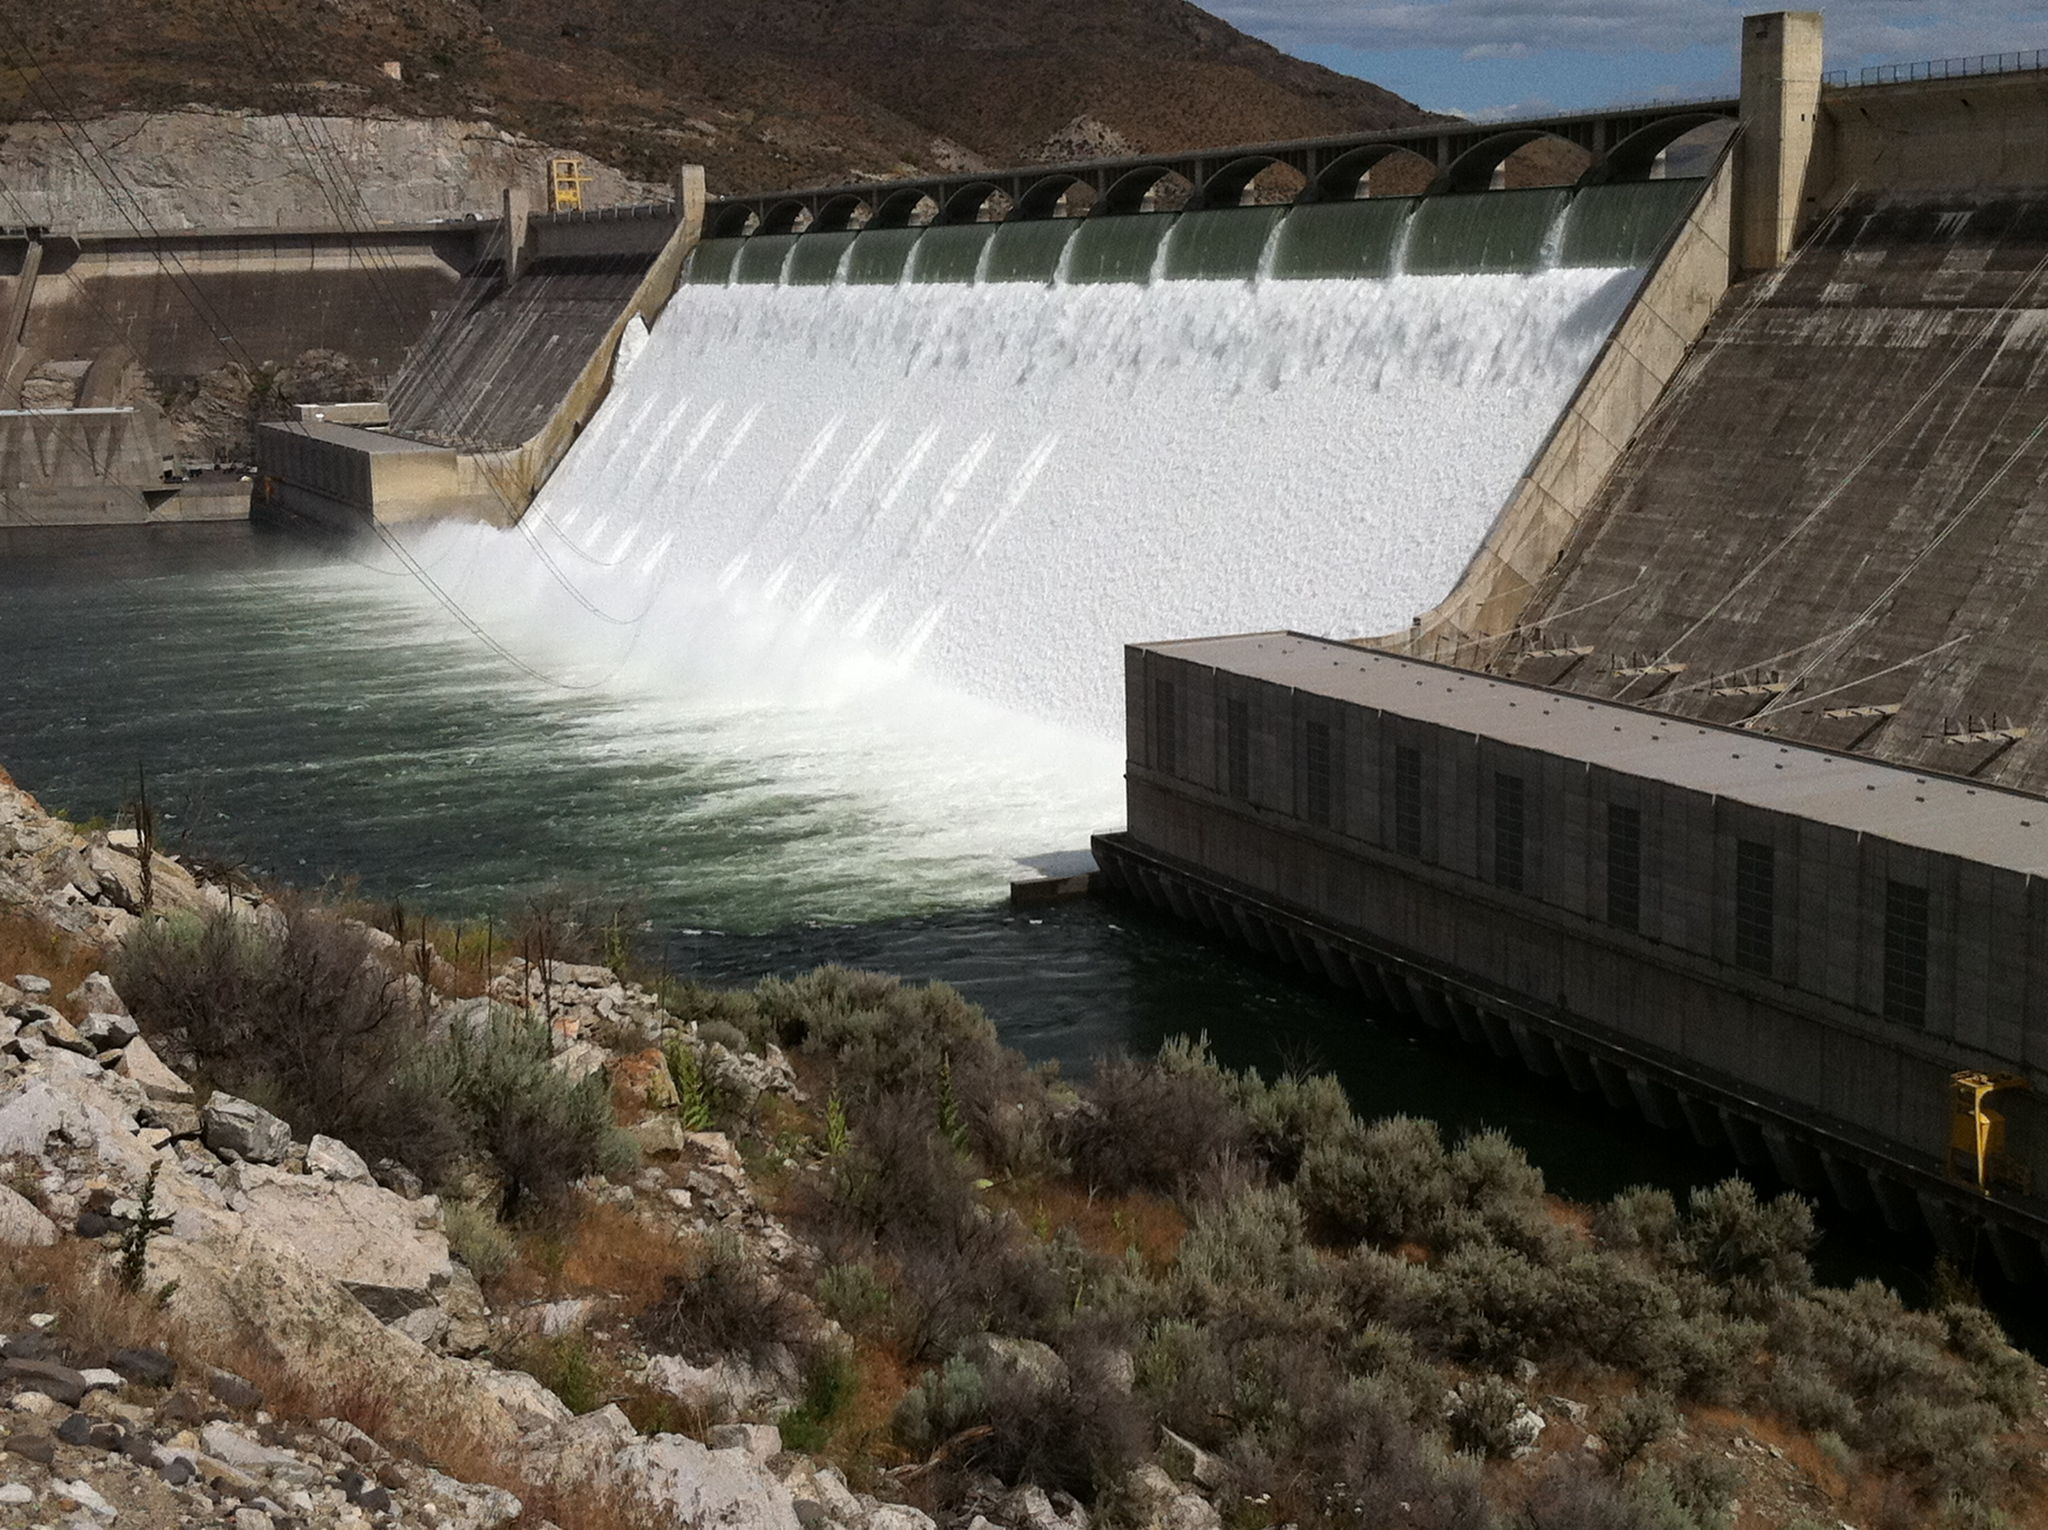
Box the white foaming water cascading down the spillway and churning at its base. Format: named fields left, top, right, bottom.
left=380, top=260, right=1638, bottom=875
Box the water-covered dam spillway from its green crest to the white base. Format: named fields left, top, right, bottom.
left=496, top=182, right=1696, bottom=735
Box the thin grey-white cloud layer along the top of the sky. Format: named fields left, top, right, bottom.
left=1210, top=0, right=2048, bottom=63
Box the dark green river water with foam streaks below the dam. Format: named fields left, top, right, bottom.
left=0, top=526, right=1982, bottom=1317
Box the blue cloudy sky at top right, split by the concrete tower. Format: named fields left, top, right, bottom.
left=1204, top=0, right=2048, bottom=119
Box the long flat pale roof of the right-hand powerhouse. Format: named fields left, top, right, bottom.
left=1139, top=633, right=2048, bottom=877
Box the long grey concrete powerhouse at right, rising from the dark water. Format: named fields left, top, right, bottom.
left=1096, top=633, right=2048, bottom=1274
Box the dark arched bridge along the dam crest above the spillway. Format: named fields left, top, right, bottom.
left=705, top=98, right=1739, bottom=238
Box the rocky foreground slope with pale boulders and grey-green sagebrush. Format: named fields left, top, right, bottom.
left=0, top=761, right=2048, bottom=1530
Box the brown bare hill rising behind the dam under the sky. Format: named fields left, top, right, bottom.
left=0, top=0, right=1430, bottom=190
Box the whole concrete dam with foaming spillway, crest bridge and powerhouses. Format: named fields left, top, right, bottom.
left=19, top=14, right=2048, bottom=1274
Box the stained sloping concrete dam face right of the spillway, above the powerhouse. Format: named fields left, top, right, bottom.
left=1505, top=190, right=2048, bottom=793
